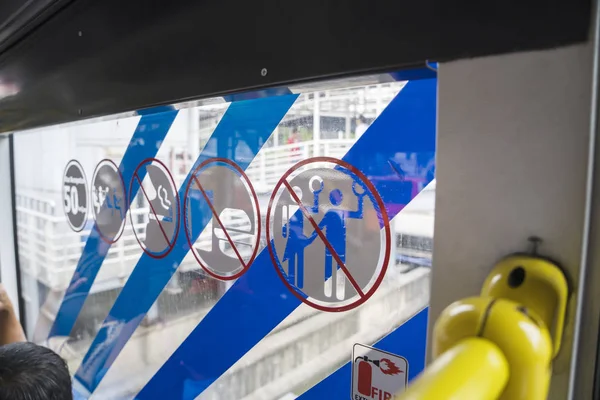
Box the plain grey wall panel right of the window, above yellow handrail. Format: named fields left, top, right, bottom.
left=429, top=45, right=595, bottom=399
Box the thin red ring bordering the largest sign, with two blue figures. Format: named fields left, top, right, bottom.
left=265, top=157, right=391, bottom=312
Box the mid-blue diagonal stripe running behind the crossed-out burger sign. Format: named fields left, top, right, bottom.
left=75, top=95, right=298, bottom=398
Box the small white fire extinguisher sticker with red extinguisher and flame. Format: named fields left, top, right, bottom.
left=352, top=343, right=408, bottom=400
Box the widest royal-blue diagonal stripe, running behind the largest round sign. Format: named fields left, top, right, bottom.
left=136, top=79, right=436, bottom=400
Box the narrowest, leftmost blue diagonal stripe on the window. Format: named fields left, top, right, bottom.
left=48, top=109, right=178, bottom=337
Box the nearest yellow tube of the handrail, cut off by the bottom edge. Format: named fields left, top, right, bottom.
left=395, top=337, right=509, bottom=400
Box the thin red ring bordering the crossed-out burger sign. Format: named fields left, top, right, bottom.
left=183, top=157, right=262, bottom=281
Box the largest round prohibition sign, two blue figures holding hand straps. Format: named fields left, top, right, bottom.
left=266, top=157, right=390, bottom=311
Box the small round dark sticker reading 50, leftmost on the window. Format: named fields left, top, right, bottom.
left=62, top=160, right=88, bottom=232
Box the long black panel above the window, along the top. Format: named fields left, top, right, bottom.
left=0, top=0, right=591, bottom=132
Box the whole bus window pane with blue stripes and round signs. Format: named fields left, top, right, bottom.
left=15, top=77, right=435, bottom=399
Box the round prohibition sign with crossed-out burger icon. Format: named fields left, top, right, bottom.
left=183, top=158, right=261, bottom=280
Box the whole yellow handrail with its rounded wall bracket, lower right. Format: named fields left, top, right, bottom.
left=394, top=248, right=569, bottom=400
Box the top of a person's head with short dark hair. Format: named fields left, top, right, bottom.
left=0, top=342, right=73, bottom=400
